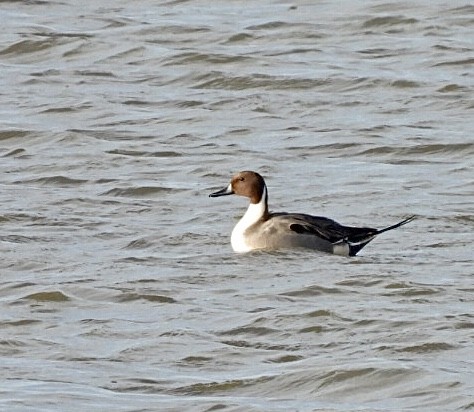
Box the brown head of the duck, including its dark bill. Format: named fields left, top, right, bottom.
left=209, top=170, right=266, bottom=204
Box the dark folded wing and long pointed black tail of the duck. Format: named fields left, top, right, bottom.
left=278, top=213, right=415, bottom=256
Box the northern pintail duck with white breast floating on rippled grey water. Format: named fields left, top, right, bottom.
left=209, top=171, right=415, bottom=256
